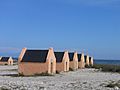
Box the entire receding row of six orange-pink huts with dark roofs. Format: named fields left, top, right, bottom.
left=18, top=48, right=93, bottom=75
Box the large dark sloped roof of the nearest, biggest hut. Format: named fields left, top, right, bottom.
left=21, top=50, right=48, bottom=63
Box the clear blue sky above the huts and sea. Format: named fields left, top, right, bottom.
left=0, top=0, right=120, bottom=60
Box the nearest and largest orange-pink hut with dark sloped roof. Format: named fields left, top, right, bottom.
left=18, top=48, right=56, bottom=75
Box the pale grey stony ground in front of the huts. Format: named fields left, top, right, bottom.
left=0, top=66, right=120, bottom=90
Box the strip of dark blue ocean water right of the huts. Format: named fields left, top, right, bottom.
left=94, top=60, right=120, bottom=65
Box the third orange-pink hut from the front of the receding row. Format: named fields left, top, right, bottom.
left=69, top=52, right=78, bottom=70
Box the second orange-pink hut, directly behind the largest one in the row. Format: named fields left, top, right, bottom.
left=55, top=51, right=69, bottom=72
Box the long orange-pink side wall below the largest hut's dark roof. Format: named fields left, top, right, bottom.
left=18, top=62, right=48, bottom=75
